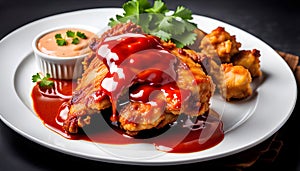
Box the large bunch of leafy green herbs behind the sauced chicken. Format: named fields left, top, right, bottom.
left=108, top=0, right=197, bottom=47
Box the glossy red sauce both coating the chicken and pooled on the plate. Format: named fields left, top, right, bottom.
left=32, top=32, right=224, bottom=153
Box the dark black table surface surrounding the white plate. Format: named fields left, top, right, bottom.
left=0, top=0, right=300, bottom=171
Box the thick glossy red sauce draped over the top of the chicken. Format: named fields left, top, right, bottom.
left=98, top=33, right=181, bottom=122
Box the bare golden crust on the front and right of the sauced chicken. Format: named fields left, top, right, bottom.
left=119, top=41, right=215, bottom=136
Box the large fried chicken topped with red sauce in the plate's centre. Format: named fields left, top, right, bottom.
left=63, top=23, right=215, bottom=135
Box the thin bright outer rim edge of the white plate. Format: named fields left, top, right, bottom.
left=0, top=8, right=298, bottom=165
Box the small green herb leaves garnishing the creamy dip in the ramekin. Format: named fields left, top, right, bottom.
left=55, top=30, right=87, bottom=46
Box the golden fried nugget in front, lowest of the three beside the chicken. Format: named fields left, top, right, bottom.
left=219, top=63, right=252, bottom=101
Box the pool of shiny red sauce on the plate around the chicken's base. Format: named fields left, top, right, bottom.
left=31, top=80, right=224, bottom=153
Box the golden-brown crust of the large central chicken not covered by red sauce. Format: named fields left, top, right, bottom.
left=63, top=23, right=215, bottom=135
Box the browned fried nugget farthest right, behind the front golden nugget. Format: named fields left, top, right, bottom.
left=231, top=49, right=262, bottom=77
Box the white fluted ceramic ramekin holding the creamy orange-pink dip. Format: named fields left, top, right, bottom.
left=32, top=25, right=98, bottom=80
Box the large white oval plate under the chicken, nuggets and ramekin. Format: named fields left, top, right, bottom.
left=0, top=8, right=297, bottom=165
